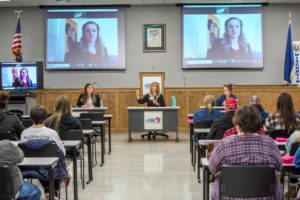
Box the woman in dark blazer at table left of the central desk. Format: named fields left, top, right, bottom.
left=76, top=83, right=101, bottom=108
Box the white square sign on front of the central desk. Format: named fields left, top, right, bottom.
left=144, top=111, right=163, bottom=130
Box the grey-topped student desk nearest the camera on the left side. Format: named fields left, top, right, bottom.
left=18, top=157, right=58, bottom=200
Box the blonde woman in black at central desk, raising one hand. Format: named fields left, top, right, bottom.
left=136, top=82, right=168, bottom=140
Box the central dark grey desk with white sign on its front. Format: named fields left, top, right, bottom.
left=127, top=107, right=180, bottom=142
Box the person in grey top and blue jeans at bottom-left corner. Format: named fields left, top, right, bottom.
left=0, top=140, right=41, bottom=200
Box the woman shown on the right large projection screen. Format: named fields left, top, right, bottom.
left=207, top=17, right=252, bottom=60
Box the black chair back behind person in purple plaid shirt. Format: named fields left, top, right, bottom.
left=219, top=166, right=276, bottom=199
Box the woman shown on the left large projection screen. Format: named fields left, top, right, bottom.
left=65, top=21, right=108, bottom=67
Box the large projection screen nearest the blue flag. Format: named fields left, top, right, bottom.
left=182, top=4, right=263, bottom=69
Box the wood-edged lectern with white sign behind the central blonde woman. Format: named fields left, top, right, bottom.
left=140, top=72, right=165, bottom=95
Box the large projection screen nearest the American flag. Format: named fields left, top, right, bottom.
left=45, top=6, right=125, bottom=70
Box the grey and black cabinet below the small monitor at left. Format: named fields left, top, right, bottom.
left=7, top=91, right=37, bottom=115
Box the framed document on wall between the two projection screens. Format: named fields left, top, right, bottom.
left=143, top=24, right=166, bottom=52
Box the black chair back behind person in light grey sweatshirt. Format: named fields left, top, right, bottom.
left=18, top=143, right=58, bottom=157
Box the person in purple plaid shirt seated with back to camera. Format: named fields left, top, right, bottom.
left=209, top=106, right=282, bottom=200
